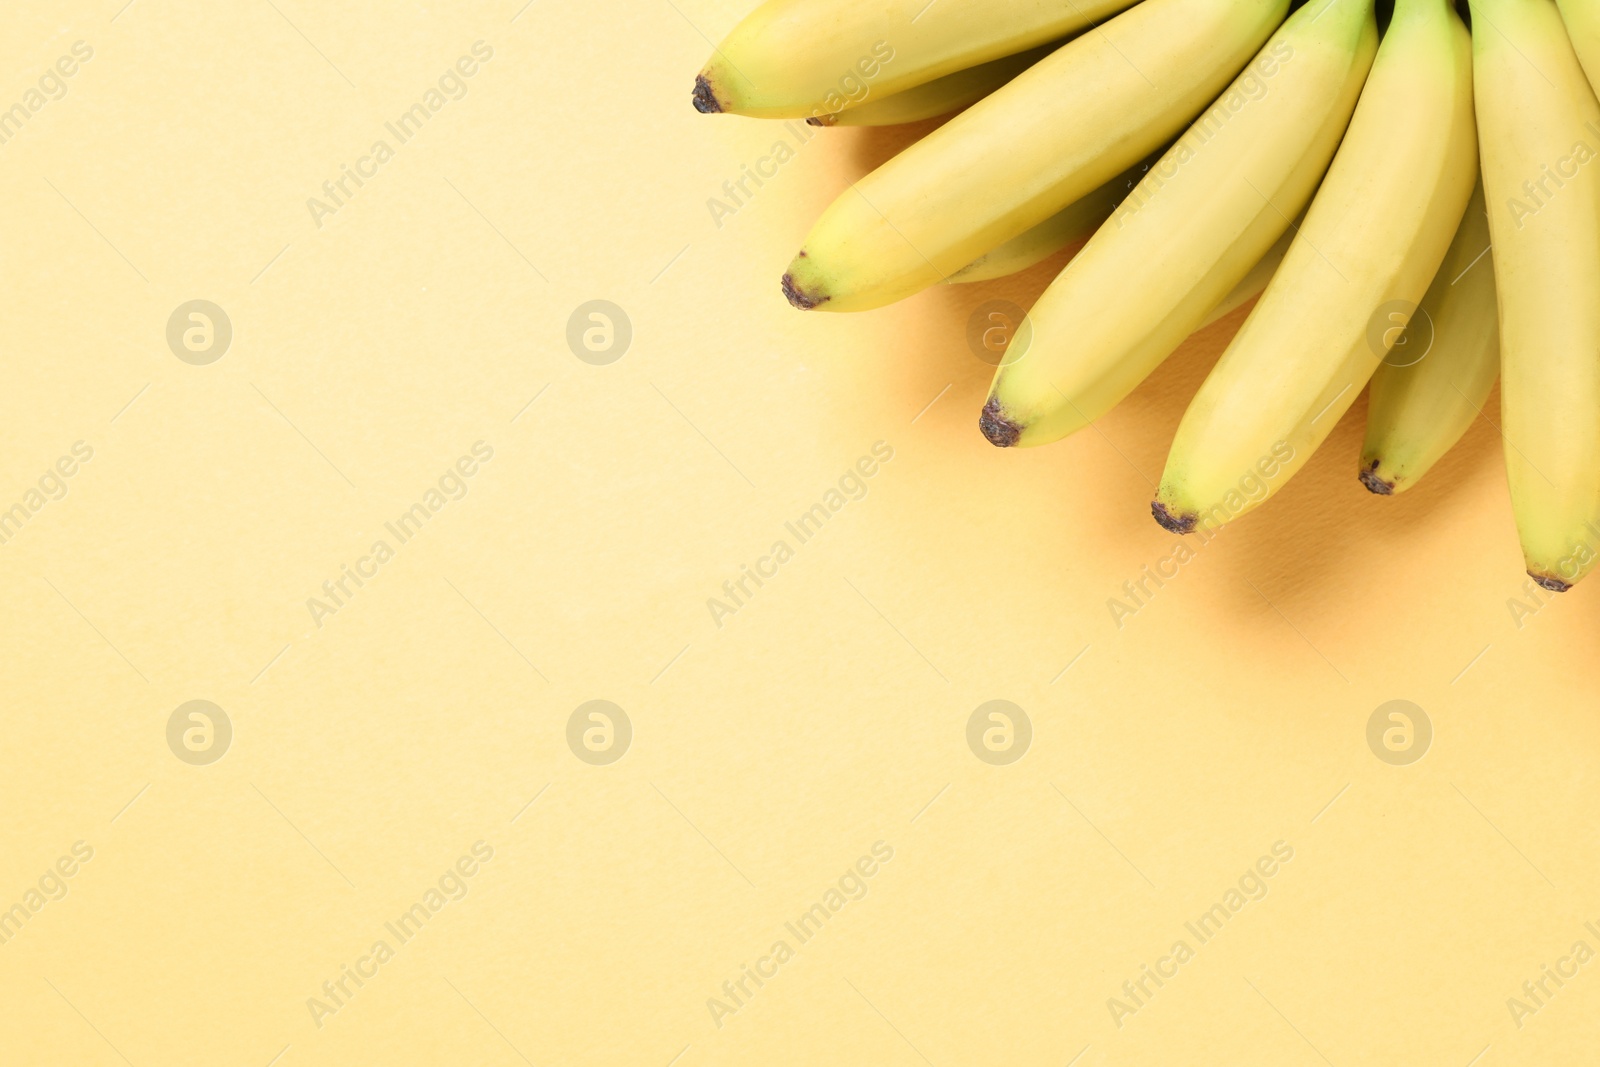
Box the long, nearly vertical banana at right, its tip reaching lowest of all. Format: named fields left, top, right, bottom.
left=1472, top=0, right=1600, bottom=592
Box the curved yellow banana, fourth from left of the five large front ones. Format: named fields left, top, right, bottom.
left=1150, top=0, right=1472, bottom=533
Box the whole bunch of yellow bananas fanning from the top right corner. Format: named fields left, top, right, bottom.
left=693, top=0, right=1600, bottom=590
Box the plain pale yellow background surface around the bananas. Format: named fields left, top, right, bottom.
left=0, top=0, right=1600, bottom=1067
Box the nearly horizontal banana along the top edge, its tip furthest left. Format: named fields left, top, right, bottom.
left=693, top=0, right=1134, bottom=118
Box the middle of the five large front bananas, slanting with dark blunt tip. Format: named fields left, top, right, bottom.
left=968, top=0, right=1378, bottom=448
